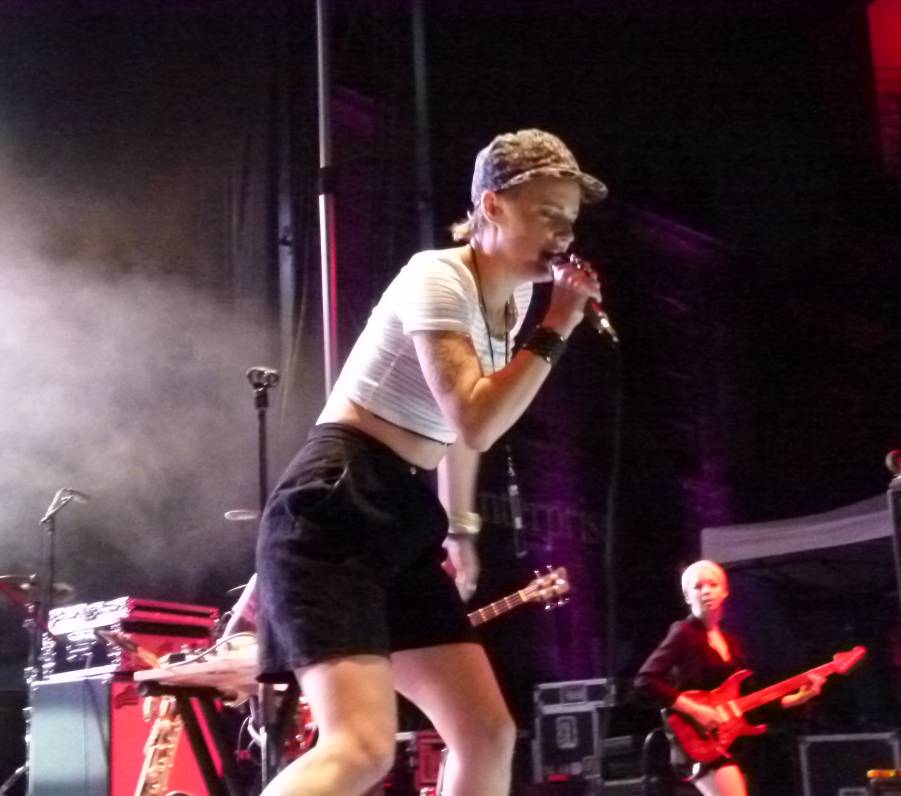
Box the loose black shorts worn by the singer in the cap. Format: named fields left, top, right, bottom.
left=257, top=423, right=475, bottom=681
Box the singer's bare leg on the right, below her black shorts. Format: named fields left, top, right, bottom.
left=391, top=644, right=516, bottom=796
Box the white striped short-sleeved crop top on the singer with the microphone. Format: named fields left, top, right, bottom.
left=319, top=249, right=532, bottom=444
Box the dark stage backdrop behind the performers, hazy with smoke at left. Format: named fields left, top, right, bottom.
left=0, top=0, right=901, bottom=764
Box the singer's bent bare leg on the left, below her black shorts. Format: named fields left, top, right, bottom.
left=263, top=655, right=397, bottom=796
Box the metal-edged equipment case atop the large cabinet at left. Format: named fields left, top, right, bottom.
left=41, top=597, right=219, bottom=676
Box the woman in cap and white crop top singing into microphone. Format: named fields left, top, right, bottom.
left=257, top=130, right=606, bottom=796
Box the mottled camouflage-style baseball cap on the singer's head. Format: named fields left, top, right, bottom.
left=471, top=129, right=607, bottom=207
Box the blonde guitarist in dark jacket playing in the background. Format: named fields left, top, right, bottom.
left=635, top=561, right=825, bottom=796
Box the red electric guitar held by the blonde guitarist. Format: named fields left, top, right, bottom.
left=664, top=646, right=867, bottom=763
